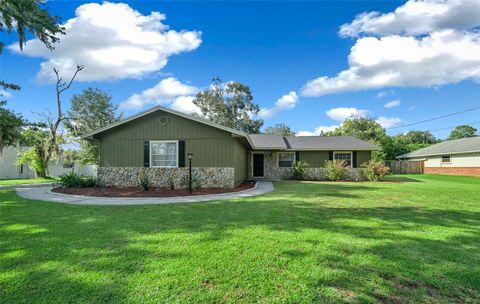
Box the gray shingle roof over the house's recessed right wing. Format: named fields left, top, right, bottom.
left=248, top=134, right=378, bottom=151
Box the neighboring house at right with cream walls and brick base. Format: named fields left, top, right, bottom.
left=397, top=137, right=480, bottom=176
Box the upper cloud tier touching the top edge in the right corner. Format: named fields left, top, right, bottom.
left=339, top=0, right=480, bottom=37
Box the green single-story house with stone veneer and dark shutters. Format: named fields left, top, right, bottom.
left=82, top=106, right=378, bottom=188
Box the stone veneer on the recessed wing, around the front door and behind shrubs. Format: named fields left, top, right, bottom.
left=248, top=151, right=365, bottom=181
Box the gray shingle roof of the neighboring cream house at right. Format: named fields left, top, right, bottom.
left=397, top=136, right=480, bottom=158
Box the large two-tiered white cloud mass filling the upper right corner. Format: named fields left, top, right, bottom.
left=301, top=0, right=480, bottom=96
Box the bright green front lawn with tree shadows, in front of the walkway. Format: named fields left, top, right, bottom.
left=0, top=175, right=480, bottom=303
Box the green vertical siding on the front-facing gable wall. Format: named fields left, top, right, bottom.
left=98, top=111, right=242, bottom=167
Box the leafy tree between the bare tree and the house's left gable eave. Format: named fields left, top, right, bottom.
left=64, top=88, right=122, bottom=165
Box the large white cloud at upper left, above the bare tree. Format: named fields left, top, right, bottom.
left=9, top=2, right=201, bottom=81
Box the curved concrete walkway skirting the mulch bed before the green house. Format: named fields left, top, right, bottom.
left=15, top=181, right=273, bottom=206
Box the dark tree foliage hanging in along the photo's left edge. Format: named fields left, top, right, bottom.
left=0, top=0, right=64, bottom=151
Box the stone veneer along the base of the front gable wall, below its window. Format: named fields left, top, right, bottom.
left=97, top=167, right=235, bottom=189
